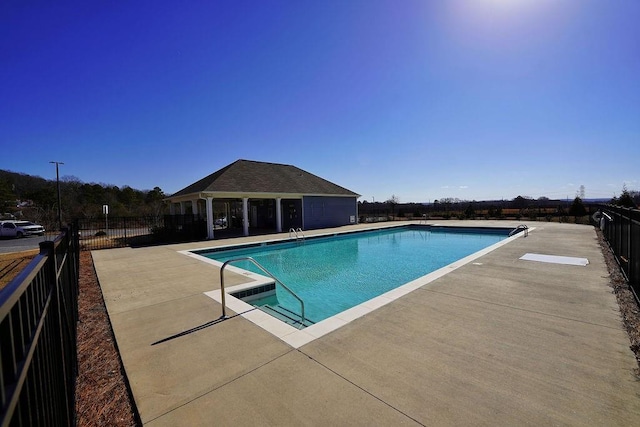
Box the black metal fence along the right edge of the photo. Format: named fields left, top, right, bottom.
left=597, top=205, right=640, bottom=304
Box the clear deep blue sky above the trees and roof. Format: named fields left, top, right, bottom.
left=0, top=0, right=640, bottom=202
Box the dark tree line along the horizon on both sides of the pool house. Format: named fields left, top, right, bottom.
left=0, top=170, right=640, bottom=229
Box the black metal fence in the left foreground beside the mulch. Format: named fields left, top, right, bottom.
left=0, top=228, right=80, bottom=426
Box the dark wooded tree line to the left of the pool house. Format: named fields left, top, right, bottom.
left=0, top=170, right=166, bottom=229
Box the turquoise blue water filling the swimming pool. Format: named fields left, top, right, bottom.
left=199, top=226, right=509, bottom=322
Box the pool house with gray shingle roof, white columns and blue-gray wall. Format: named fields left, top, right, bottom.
left=167, top=160, right=360, bottom=239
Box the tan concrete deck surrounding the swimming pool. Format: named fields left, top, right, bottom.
left=92, top=221, right=640, bottom=426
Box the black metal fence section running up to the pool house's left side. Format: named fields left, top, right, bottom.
left=74, top=214, right=207, bottom=250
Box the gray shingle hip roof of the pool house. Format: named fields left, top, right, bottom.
left=172, top=160, right=359, bottom=197
